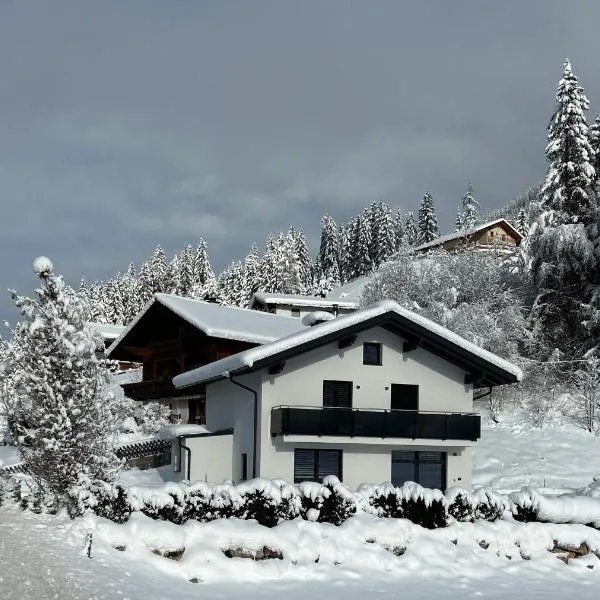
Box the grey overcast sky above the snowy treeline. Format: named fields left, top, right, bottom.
left=0, top=0, right=600, bottom=320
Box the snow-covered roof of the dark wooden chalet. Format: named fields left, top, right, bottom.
left=107, top=294, right=304, bottom=355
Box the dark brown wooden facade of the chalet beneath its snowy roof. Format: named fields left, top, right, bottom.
left=110, top=303, right=256, bottom=424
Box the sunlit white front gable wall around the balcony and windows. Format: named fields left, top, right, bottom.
left=259, top=327, right=473, bottom=488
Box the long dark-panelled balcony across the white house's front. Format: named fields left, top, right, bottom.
left=271, top=406, right=481, bottom=442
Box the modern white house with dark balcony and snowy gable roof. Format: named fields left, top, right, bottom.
left=173, top=301, right=521, bottom=489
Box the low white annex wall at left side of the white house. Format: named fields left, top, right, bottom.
left=171, top=435, right=233, bottom=483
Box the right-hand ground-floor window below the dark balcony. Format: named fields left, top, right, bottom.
left=392, top=450, right=446, bottom=491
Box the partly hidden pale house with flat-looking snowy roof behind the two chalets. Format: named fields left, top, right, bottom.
left=248, top=292, right=357, bottom=318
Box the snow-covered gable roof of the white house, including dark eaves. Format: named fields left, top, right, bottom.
left=173, top=300, right=523, bottom=388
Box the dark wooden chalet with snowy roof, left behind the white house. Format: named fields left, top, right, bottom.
left=107, top=294, right=304, bottom=423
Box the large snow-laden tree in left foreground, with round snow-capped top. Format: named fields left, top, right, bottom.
left=5, top=257, right=120, bottom=499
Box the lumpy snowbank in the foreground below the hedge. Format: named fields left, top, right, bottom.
left=74, top=513, right=600, bottom=582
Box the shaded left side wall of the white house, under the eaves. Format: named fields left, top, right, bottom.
left=206, top=374, right=261, bottom=481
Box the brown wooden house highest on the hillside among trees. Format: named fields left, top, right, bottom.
left=414, top=219, right=523, bottom=254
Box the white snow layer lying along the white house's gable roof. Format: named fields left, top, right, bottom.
left=173, top=300, right=523, bottom=388
